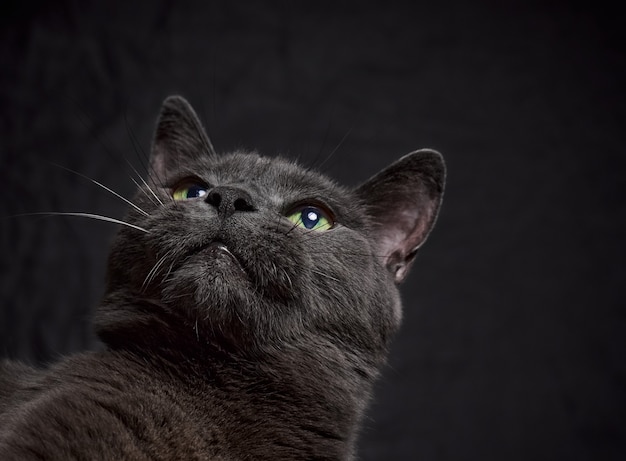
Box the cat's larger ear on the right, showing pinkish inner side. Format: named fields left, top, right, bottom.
left=357, top=149, right=445, bottom=283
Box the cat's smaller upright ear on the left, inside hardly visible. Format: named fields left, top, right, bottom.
left=150, top=96, right=215, bottom=182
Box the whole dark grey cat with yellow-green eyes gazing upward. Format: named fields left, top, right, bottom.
left=0, top=97, right=444, bottom=460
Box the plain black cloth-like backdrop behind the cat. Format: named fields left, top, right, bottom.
left=0, top=1, right=626, bottom=460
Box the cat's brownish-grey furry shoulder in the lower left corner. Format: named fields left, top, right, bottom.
left=0, top=351, right=220, bottom=459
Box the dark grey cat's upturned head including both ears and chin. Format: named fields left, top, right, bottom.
left=96, top=97, right=445, bottom=357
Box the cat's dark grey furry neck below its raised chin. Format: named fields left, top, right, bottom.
left=95, top=296, right=377, bottom=459
